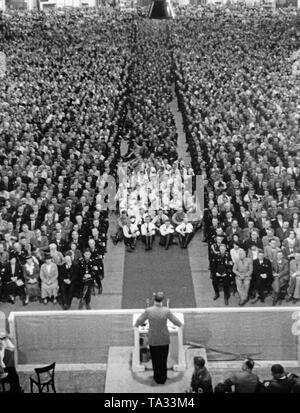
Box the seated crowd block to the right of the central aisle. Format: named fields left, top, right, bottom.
left=172, top=6, right=300, bottom=305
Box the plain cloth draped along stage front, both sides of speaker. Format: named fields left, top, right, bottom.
left=15, top=308, right=297, bottom=365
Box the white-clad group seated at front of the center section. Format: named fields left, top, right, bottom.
left=112, top=160, right=202, bottom=252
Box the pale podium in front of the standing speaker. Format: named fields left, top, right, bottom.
left=132, top=313, right=186, bottom=372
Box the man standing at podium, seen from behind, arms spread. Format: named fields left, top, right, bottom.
left=135, top=292, right=182, bottom=384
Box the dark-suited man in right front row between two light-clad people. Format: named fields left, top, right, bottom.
left=252, top=250, right=272, bottom=304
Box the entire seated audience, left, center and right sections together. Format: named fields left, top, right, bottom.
left=0, top=6, right=300, bottom=309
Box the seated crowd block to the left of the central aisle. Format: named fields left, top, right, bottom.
left=0, top=9, right=134, bottom=309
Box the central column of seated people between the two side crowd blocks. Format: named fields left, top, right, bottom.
left=113, top=20, right=202, bottom=252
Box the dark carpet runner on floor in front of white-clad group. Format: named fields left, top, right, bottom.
left=122, top=238, right=196, bottom=308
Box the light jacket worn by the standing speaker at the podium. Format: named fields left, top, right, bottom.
left=135, top=305, right=181, bottom=346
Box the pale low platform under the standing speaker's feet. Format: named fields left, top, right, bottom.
left=105, top=347, right=206, bottom=393
